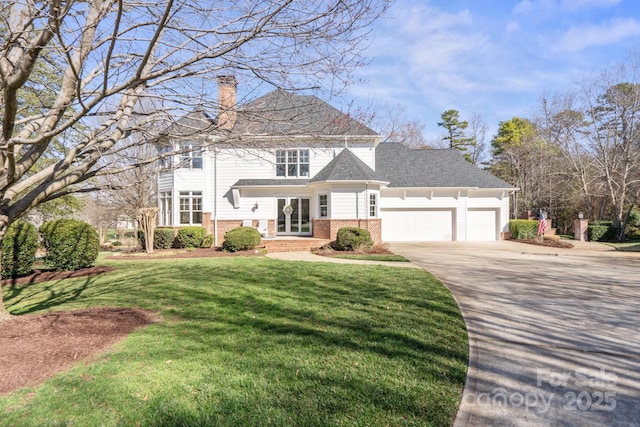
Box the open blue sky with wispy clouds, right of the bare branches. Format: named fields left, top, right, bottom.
left=345, top=0, right=640, bottom=143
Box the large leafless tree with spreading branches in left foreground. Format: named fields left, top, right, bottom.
left=0, top=0, right=388, bottom=318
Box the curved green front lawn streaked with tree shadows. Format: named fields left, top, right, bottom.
left=0, top=257, right=467, bottom=426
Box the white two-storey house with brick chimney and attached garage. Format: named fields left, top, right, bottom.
left=158, top=76, right=515, bottom=242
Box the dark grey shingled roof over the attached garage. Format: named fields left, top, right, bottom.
left=376, top=142, right=516, bottom=190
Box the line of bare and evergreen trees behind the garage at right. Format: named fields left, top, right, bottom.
left=378, top=54, right=640, bottom=240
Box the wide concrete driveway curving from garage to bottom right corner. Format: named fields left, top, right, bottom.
left=390, top=242, right=640, bottom=427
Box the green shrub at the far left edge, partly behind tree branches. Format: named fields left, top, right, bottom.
left=2, top=221, right=39, bottom=279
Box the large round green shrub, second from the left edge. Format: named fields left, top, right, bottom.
left=40, top=219, right=100, bottom=271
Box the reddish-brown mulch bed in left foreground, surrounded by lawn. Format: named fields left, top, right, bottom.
left=0, top=307, right=159, bottom=394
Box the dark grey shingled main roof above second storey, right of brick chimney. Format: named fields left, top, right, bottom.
left=232, top=89, right=378, bottom=136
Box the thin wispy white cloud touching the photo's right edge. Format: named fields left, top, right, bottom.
left=552, top=18, right=640, bottom=52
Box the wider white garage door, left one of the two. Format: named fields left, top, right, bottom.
left=380, top=209, right=453, bottom=242
